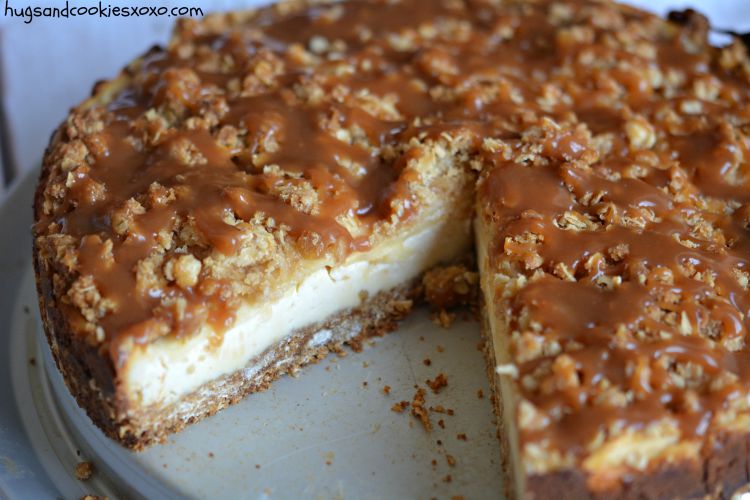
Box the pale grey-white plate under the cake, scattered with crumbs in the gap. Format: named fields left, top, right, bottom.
left=0, top=170, right=502, bottom=499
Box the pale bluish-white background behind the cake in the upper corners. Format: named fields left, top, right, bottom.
left=0, top=0, right=750, bottom=199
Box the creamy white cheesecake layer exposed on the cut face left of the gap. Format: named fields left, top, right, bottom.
left=124, top=218, right=471, bottom=407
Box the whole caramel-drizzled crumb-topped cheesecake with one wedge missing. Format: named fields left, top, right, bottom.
left=33, top=0, right=750, bottom=498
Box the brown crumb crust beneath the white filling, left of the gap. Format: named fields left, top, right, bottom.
left=35, top=250, right=420, bottom=451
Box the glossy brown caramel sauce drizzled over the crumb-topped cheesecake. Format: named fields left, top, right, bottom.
left=36, top=0, right=750, bottom=457
